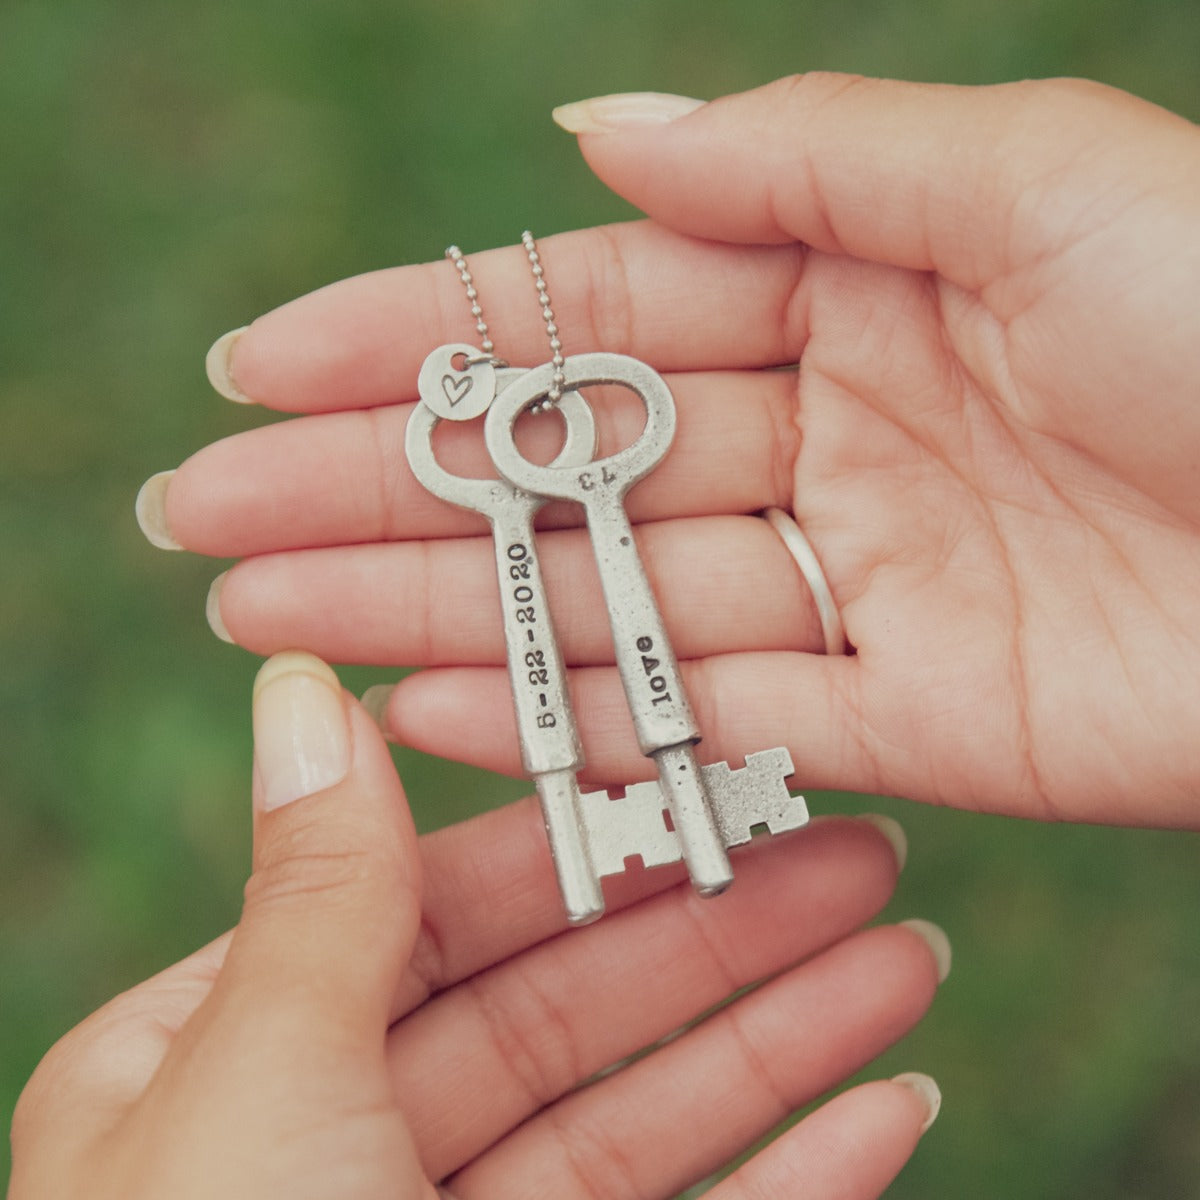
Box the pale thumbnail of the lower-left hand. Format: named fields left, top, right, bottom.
left=254, top=650, right=350, bottom=812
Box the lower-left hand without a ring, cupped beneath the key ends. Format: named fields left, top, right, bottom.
left=10, top=652, right=948, bottom=1200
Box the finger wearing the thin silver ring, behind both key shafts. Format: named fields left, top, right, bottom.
left=209, top=517, right=822, bottom=666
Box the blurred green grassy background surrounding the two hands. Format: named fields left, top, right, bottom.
left=0, top=0, right=1200, bottom=1200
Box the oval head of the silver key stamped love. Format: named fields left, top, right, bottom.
left=485, top=354, right=676, bottom=504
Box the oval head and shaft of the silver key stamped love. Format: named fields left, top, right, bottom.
left=485, top=354, right=733, bottom=895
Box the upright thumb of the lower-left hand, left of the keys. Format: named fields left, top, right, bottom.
left=218, top=652, right=421, bottom=1042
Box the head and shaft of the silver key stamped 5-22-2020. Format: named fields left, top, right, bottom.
left=404, top=369, right=604, bottom=924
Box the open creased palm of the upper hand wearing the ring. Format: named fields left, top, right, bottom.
left=796, top=194, right=1200, bottom=822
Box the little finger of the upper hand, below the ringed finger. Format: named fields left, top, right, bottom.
left=380, top=650, right=864, bottom=799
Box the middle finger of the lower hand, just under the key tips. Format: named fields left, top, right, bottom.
left=389, top=822, right=898, bottom=1178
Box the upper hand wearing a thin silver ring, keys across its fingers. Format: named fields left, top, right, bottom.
left=140, top=76, right=1200, bottom=826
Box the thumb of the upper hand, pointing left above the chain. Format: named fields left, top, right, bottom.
left=556, top=73, right=1192, bottom=289
